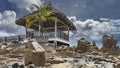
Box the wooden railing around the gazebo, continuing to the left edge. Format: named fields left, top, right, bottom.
left=0, top=31, right=69, bottom=42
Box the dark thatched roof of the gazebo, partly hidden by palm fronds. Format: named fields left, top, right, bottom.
left=16, top=4, right=76, bottom=31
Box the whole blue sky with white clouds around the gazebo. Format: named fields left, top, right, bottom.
left=0, top=0, right=120, bottom=47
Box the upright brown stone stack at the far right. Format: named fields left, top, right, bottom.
left=101, top=34, right=120, bottom=54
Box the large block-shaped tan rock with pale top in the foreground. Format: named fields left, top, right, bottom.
left=25, top=42, right=46, bottom=66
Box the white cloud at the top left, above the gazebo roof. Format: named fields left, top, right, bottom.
left=8, top=0, right=42, bottom=12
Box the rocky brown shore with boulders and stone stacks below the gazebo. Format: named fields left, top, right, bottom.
left=0, top=36, right=120, bottom=68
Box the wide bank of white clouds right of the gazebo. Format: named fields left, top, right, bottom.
left=68, top=16, right=120, bottom=40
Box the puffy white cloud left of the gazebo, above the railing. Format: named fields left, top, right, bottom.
left=0, top=11, right=25, bottom=37
